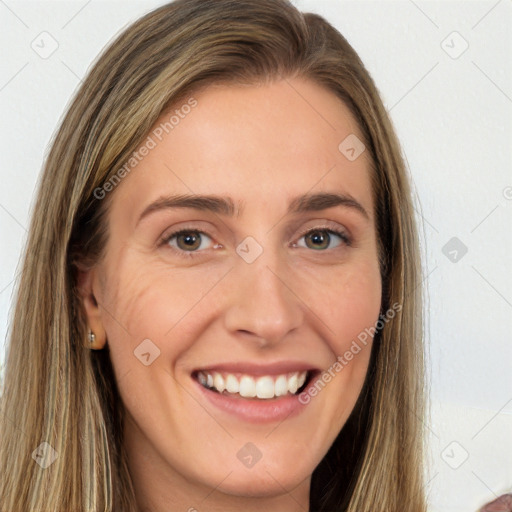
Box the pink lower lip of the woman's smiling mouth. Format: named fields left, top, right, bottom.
left=192, top=378, right=315, bottom=423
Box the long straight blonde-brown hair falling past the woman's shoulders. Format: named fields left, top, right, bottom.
left=0, top=0, right=425, bottom=512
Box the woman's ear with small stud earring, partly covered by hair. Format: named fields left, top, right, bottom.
left=77, top=267, right=107, bottom=350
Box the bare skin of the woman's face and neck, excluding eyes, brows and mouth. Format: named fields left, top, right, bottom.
left=81, top=78, right=381, bottom=512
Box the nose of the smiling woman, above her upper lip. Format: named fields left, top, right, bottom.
left=224, top=256, right=304, bottom=347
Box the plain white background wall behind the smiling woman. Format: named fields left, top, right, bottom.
left=0, top=0, right=512, bottom=512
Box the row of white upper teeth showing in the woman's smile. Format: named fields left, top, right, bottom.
left=197, top=371, right=308, bottom=399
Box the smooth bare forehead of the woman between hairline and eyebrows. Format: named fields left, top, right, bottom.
left=109, top=79, right=372, bottom=220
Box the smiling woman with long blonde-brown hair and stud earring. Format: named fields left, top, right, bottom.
left=0, top=0, right=426, bottom=512
